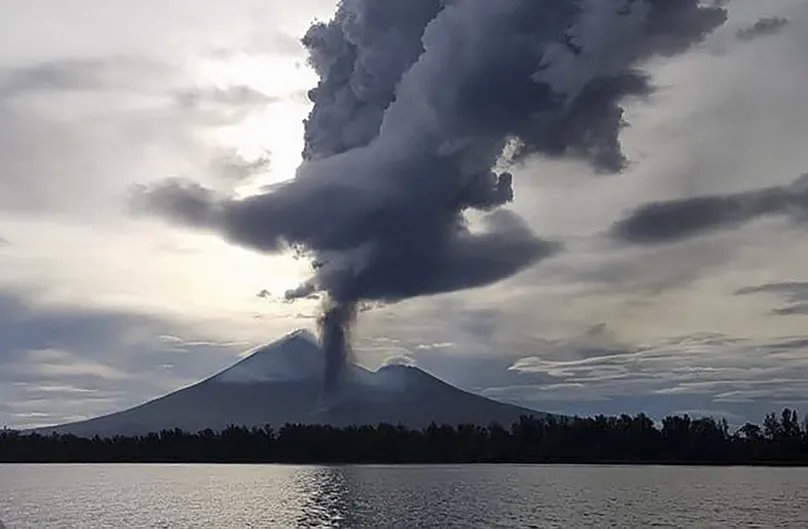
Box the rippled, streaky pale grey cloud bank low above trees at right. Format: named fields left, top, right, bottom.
left=502, top=333, right=808, bottom=417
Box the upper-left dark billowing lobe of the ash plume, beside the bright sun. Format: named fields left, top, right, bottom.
left=301, top=0, right=444, bottom=158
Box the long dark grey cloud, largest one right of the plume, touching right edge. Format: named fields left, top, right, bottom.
left=611, top=175, right=808, bottom=244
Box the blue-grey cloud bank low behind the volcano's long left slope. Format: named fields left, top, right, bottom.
left=0, top=291, right=247, bottom=425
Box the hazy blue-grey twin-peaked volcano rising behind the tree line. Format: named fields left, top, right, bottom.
left=39, top=330, right=544, bottom=436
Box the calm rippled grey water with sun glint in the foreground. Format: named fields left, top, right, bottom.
left=0, top=465, right=808, bottom=529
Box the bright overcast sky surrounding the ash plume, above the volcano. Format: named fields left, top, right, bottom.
left=0, top=0, right=808, bottom=428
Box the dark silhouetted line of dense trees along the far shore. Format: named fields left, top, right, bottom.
left=0, top=409, right=808, bottom=465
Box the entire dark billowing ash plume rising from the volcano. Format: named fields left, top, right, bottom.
left=136, top=0, right=726, bottom=394
